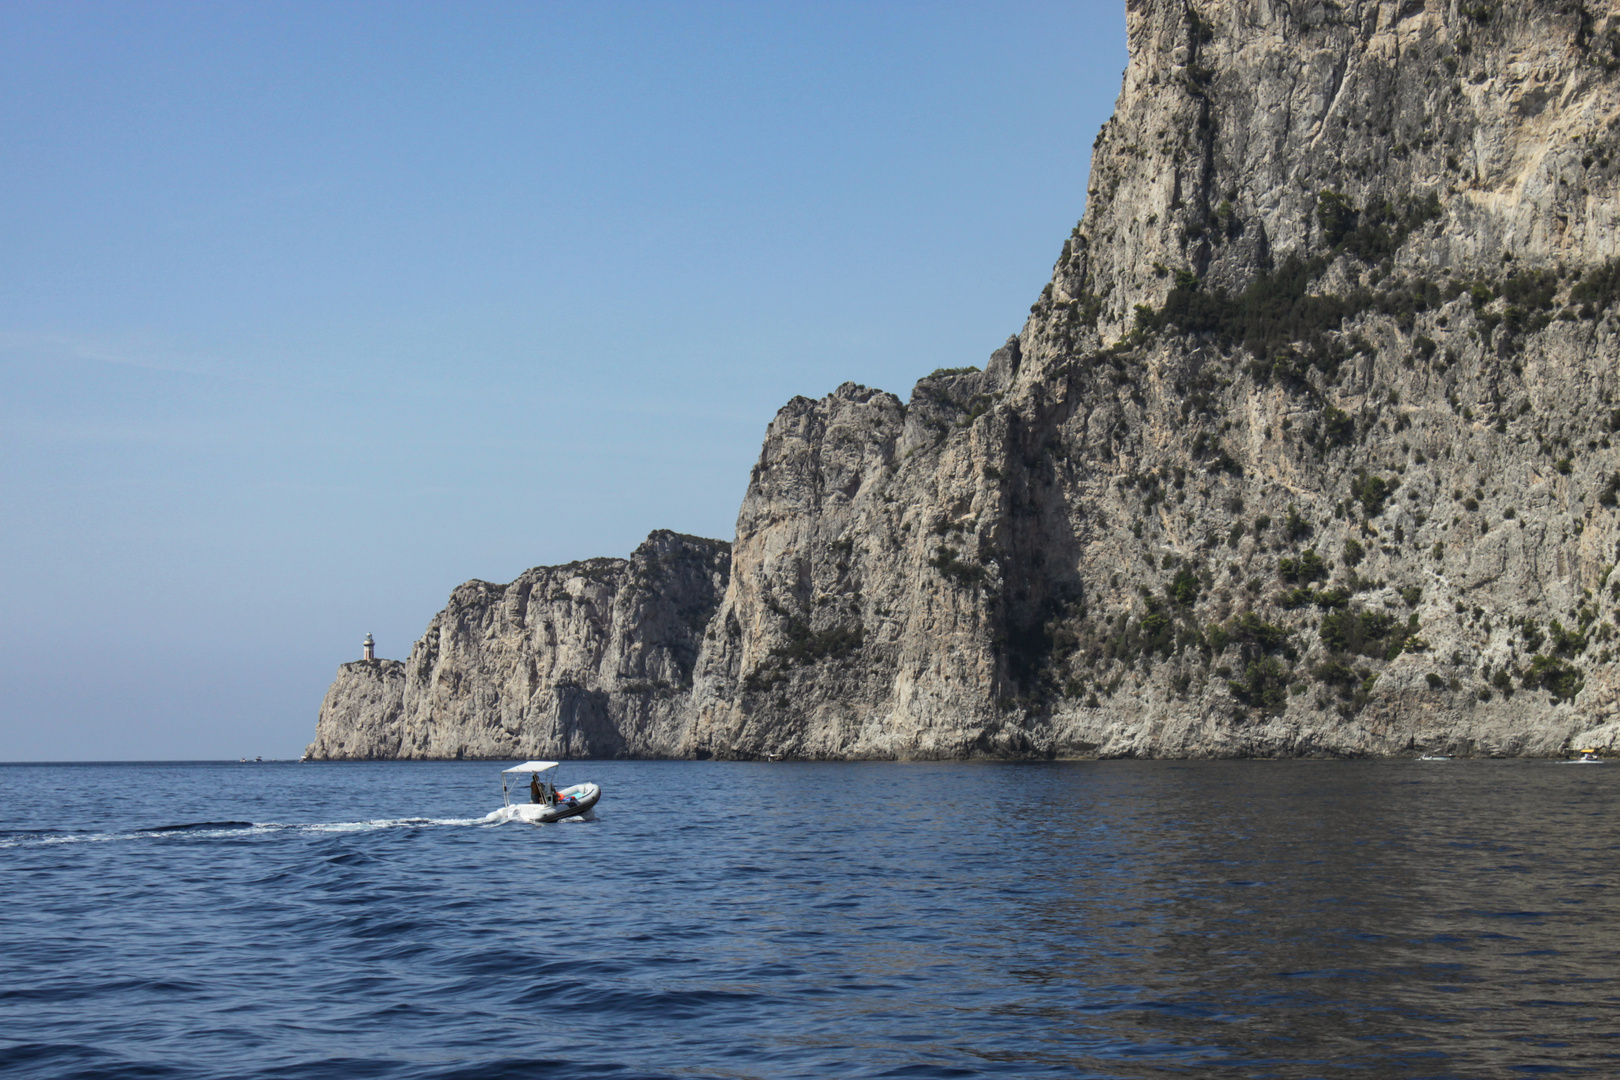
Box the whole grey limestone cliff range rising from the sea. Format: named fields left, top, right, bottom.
left=311, top=0, right=1620, bottom=758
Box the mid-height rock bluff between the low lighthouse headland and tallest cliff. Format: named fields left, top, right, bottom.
left=690, top=377, right=1022, bottom=756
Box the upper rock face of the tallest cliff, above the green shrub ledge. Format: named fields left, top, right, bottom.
left=1062, top=0, right=1620, bottom=340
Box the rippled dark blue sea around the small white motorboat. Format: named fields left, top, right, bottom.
left=0, top=761, right=1620, bottom=1080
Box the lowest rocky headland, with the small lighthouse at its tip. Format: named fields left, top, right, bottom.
left=305, top=531, right=731, bottom=759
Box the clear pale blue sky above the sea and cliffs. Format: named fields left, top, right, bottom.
left=0, top=0, right=1126, bottom=761
